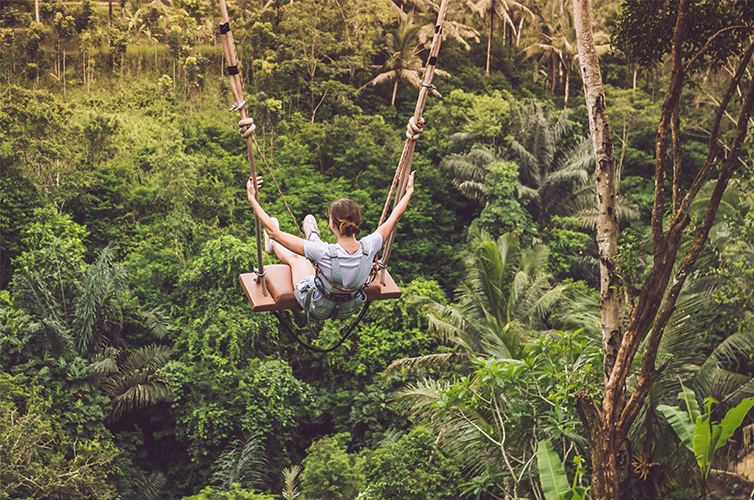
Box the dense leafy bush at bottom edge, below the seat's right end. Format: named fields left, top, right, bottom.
left=364, top=426, right=461, bottom=500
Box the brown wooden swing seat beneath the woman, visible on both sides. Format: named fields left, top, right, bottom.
left=238, top=264, right=401, bottom=312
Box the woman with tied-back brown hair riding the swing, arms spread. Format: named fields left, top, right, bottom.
left=246, top=172, right=414, bottom=319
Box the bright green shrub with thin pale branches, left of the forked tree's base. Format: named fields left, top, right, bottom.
left=398, top=331, right=602, bottom=498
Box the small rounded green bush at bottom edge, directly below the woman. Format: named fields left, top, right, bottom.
left=301, top=433, right=364, bottom=500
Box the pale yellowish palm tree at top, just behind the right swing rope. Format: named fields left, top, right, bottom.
left=361, top=16, right=450, bottom=106
